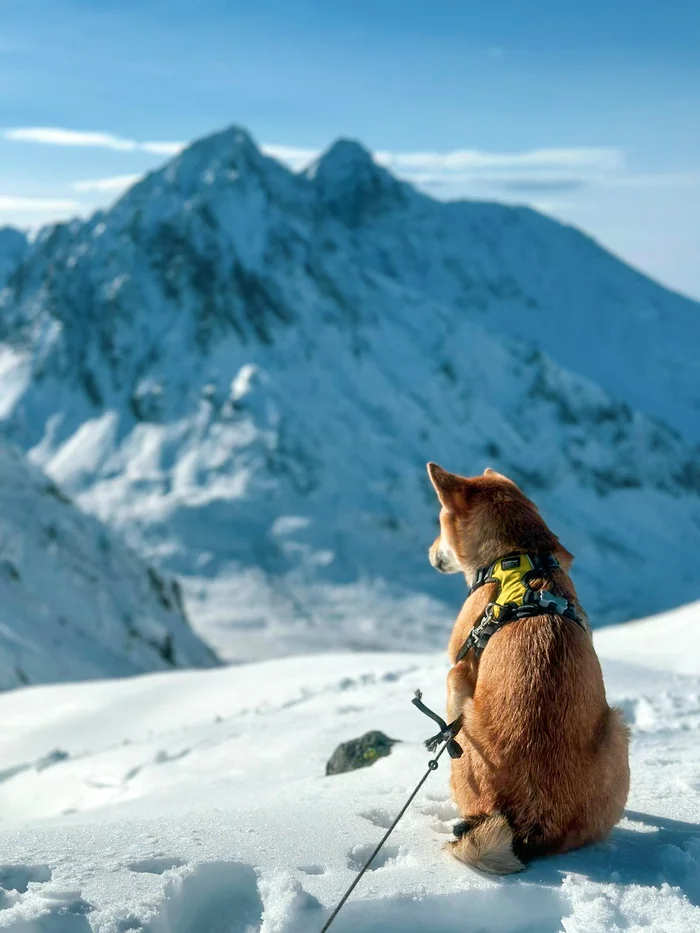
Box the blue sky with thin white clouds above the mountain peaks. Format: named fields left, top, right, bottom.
left=0, top=0, right=700, bottom=298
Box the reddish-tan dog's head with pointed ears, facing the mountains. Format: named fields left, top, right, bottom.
left=428, top=463, right=573, bottom=580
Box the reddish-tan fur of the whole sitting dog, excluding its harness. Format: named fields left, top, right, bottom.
left=428, top=463, right=629, bottom=874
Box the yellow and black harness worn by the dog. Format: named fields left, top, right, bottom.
left=457, top=554, right=585, bottom=661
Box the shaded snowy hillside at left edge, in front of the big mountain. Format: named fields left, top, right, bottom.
left=0, top=434, right=215, bottom=688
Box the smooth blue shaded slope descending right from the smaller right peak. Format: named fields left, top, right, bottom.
left=307, top=141, right=700, bottom=441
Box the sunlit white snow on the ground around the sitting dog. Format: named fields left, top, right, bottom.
left=0, top=604, right=700, bottom=933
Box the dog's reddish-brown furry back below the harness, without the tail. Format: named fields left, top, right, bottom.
left=452, top=616, right=629, bottom=867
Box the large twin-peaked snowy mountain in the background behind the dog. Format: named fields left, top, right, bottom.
left=0, top=127, right=700, bottom=660
